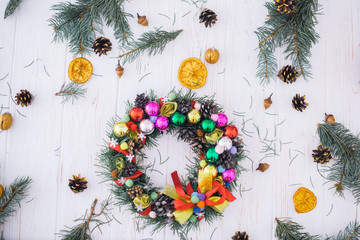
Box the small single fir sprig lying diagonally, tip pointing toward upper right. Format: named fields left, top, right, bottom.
left=118, top=29, right=183, bottom=63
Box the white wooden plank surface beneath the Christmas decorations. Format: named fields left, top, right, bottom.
left=0, top=0, right=360, bottom=240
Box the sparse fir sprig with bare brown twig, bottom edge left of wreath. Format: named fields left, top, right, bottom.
left=59, top=198, right=112, bottom=240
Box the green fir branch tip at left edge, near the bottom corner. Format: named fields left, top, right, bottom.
left=0, top=177, right=31, bottom=225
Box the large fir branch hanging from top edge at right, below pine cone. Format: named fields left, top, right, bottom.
left=255, top=0, right=320, bottom=83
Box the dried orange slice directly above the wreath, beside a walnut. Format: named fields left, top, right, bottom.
left=178, top=58, right=207, bottom=89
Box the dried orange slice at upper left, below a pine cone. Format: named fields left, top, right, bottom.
left=68, top=57, right=93, bottom=83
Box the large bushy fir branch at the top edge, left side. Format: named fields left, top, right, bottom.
left=49, top=0, right=132, bottom=56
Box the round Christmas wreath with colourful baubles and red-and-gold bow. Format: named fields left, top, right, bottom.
left=100, top=91, right=244, bottom=236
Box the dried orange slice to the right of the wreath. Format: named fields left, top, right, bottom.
left=293, top=187, right=316, bottom=213
